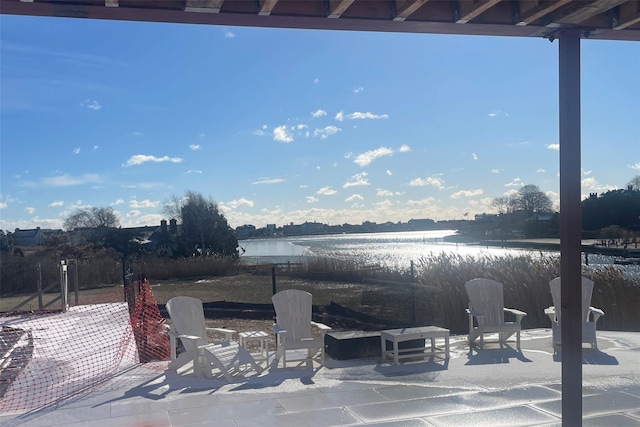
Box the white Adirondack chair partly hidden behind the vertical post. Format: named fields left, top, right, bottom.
left=544, top=277, right=604, bottom=351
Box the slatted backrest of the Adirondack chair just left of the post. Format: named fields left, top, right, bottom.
left=464, top=278, right=504, bottom=325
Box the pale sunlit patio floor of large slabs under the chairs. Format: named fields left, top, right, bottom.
left=0, top=329, right=640, bottom=427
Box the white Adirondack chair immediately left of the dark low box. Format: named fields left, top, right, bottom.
left=271, top=289, right=331, bottom=368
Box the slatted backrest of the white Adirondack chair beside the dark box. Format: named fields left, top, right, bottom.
left=272, top=289, right=313, bottom=341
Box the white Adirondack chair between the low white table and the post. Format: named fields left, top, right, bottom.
left=464, top=279, right=527, bottom=350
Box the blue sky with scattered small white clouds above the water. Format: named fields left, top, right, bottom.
left=0, top=15, right=640, bottom=231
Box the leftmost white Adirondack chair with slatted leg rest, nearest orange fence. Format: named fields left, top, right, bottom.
left=166, top=297, right=262, bottom=382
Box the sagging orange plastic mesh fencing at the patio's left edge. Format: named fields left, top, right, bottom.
left=0, top=282, right=170, bottom=414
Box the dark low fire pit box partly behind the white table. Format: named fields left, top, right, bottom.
left=324, top=331, right=424, bottom=360
